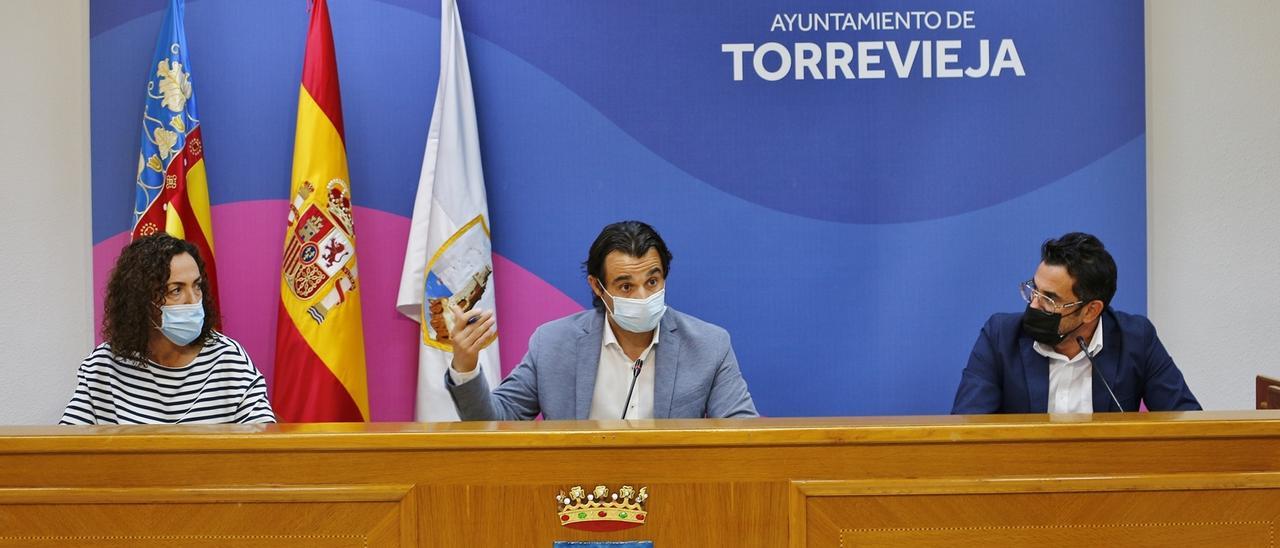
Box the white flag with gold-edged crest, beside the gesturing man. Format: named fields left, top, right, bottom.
left=396, top=0, right=499, bottom=421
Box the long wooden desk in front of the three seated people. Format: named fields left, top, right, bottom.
left=0, top=411, right=1280, bottom=548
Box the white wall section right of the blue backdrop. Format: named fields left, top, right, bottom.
left=1147, top=0, right=1280, bottom=410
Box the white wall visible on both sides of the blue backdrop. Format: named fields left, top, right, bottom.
left=0, top=0, right=1280, bottom=424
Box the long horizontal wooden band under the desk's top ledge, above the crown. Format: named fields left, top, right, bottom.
left=0, top=437, right=1280, bottom=496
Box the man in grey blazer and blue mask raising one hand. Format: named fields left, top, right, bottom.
left=444, top=222, right=758, bottom=420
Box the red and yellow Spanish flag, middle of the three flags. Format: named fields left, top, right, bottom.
left=271, top=0, right=369, bottom=423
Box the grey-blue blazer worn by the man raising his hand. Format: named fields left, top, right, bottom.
left=444, top=307, right=759, bottom=420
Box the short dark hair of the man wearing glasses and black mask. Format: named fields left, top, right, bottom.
left=1041, top=232, right=1116, bottom=306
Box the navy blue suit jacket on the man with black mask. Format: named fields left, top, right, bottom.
left=951, top=307, right=1201, bottom=415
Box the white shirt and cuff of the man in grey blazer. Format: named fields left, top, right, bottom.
left=449, top=320, right=662, bottom=420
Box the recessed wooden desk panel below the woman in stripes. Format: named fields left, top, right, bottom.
left=0, top=485, right=417, bottom=547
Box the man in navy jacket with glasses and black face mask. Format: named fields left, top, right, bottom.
left=951, top=232, right=1201, bottom=415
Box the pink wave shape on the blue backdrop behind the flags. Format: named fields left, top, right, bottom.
left=93, top=200, right=582, bottom=421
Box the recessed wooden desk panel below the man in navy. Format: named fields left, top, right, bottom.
left=791, top=472, right=1280, bottom=547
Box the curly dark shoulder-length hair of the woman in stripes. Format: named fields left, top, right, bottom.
left=102, top=232, right=218, bottom=361
